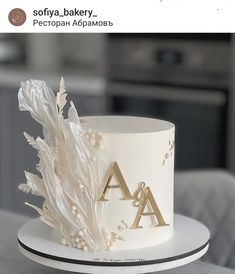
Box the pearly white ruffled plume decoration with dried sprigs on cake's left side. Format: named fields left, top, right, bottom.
left=18, top=78, right=108, bottom=250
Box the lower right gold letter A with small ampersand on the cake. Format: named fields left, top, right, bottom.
left=130, top=183, right=168, bottom=229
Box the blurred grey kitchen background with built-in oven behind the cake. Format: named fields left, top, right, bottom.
left=0, top=34, right=235, bottom=214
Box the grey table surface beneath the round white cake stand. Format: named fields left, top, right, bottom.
left=0, top=210, right=235, bottom=274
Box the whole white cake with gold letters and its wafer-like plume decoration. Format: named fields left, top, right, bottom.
left=18, top=79, right=174, bottom=251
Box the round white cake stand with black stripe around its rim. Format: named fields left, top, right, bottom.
left=18, top=215, right=210, bottom=274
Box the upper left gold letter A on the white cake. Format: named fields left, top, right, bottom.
left=98, top=162, right=132, bottom=201
